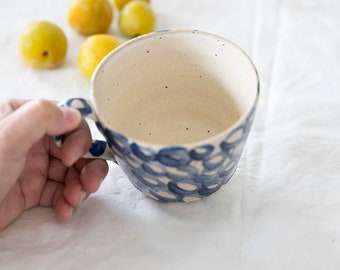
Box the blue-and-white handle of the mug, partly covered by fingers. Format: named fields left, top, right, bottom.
left=53, top=98, right=116, bottom=162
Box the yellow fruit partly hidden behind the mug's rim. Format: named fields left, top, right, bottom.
left=78, top=34, right=121, bottom=78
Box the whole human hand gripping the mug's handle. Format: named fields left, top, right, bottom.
left=0, top=100, right=108, bottom=230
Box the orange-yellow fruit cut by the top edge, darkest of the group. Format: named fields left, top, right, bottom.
left=68, top=0, right=113, bottom=36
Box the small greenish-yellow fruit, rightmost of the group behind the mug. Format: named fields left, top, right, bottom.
left=118, top=0, right=156, bottom=38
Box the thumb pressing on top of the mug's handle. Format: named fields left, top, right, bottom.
left=0, top=100, right=81, bottom=159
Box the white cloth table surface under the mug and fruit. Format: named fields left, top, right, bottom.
left=0, top=0, right=340, bottom=270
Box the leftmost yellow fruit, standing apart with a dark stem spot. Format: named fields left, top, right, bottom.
left=19, top=21, right=67, bottom=69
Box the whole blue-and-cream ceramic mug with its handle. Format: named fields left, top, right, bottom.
left=58, top=30, right=259, bottom=202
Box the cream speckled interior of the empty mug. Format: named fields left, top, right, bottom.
left=92, top=30, right=258, bottom=145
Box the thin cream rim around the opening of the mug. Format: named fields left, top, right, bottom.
left=90, top=29, right=260, bottom=149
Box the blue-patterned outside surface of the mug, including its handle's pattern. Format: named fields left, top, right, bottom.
left=61, top=98, right=255, bottom=202
